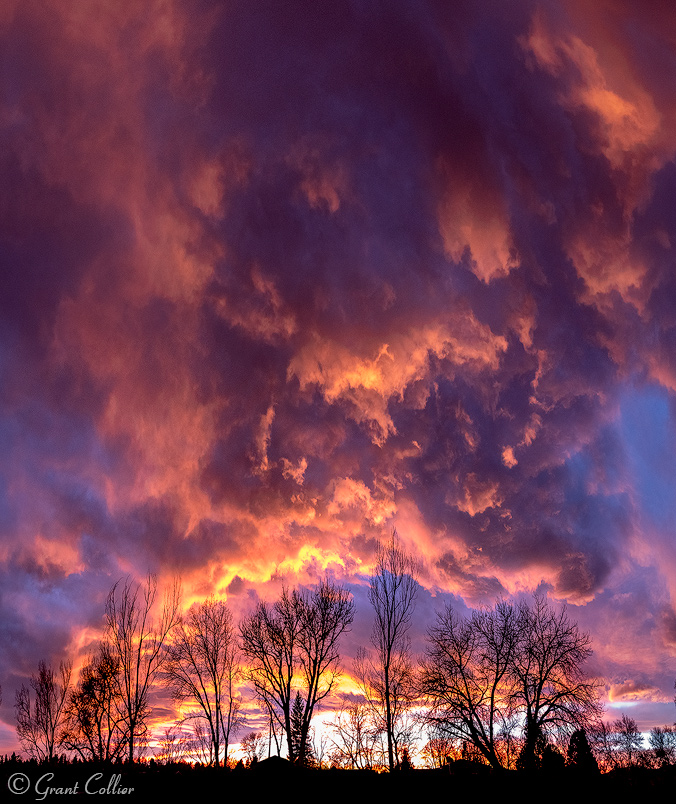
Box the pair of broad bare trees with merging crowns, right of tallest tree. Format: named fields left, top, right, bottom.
left=419, top=596, right=601, bottom=768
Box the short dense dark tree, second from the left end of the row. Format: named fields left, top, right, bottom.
left=64, top=642, right=128, bottom=761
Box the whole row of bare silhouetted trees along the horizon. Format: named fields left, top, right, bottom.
left=6, top=532, right=676, bottom=770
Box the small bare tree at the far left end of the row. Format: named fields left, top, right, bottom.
left=14, top=661, right=73, bottom=761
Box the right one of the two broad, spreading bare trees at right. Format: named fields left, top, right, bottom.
left=511, top=595, right=601, bottom=767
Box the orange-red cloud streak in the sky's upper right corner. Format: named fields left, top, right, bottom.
left=522, top=3, right=676, bottom=310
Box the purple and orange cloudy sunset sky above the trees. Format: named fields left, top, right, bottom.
left=0, top=0, right=676, bottom=751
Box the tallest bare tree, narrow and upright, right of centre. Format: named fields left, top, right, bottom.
left=354, top=530, right=418, bottom=770
